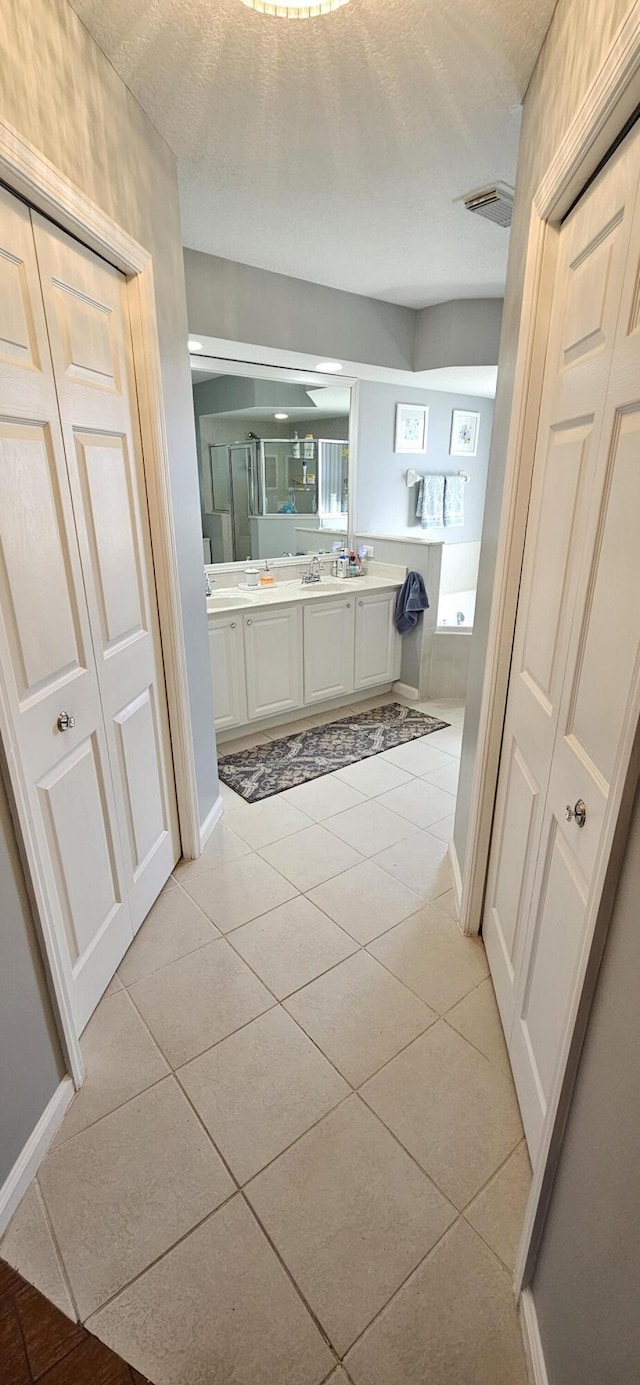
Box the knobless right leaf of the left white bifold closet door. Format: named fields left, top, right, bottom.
left=33, top=213, right=180, bottom=929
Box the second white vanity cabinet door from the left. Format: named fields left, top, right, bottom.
left=244, top=605, right=302, bottom=722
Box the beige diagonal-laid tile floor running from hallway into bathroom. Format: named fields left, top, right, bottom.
left=0, top=699, right=531, bottom=1385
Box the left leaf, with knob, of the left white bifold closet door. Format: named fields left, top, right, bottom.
left=0, top=188, right=133, bottom=1032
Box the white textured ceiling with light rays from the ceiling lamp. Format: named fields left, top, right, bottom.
left=71, top=0, right=554, bottom=307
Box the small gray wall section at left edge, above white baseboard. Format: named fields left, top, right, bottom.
left=0, top=765, right=64, bottom=1187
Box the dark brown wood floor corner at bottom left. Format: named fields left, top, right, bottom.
left=0, top=1260, right=145, bottom=1385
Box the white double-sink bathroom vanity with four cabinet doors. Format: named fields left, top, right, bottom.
left=206, top=576, right=402, bottom=740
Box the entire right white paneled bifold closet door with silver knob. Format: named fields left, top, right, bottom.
left=483, top=116, right=640, bottom=1162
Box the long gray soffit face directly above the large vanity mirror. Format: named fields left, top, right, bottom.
left=184, top=249, right=416, bottom=370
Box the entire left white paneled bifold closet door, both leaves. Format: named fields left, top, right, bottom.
left=0, top=190, right=179, bottom=1032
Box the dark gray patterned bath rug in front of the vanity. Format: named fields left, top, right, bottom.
left=219, top=702, right=449, bottom=803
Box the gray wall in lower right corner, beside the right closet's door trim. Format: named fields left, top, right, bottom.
left=532, top=775, right=640, bottom=1385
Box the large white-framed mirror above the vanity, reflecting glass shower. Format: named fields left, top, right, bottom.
left=191, top=359, right=350, bottom=564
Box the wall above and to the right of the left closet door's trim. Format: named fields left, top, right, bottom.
left=0, top=0, right=217, bottom=820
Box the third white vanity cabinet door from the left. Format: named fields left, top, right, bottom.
left=303, top=598, right=356, bottom=702
